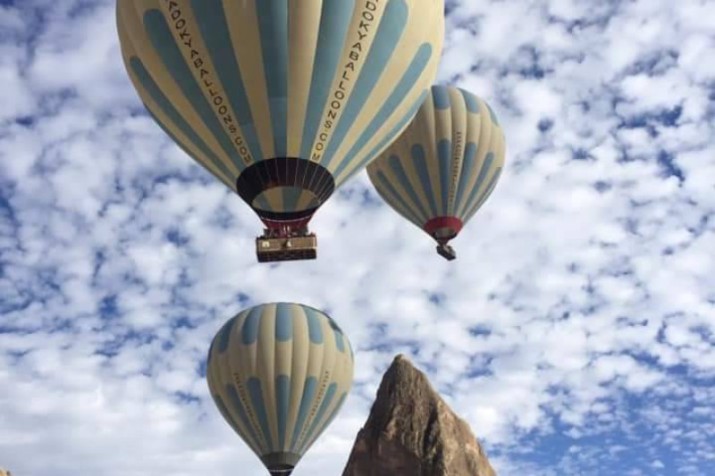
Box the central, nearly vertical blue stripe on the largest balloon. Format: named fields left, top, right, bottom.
left=255, top=0, right=288, bottom=157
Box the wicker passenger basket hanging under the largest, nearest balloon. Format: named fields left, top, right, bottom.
left=256, top=230, right=318, bottom=263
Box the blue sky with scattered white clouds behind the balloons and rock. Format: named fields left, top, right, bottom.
left=0, top=0, right=715, bottom=476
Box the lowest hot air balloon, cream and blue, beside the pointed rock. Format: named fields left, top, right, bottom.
left=207, top=303, right=353, bottom=476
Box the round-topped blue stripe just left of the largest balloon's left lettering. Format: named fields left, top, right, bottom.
left=144, top=9, right=245, bottom=170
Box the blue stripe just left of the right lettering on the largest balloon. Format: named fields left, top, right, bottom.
left=300, top=0, right=355, bottom=159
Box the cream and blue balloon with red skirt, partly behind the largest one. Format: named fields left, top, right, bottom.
left=367, top=86, right=506, bottom=260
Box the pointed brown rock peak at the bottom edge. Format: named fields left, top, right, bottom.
left=343, top=355, right=496, bottom=476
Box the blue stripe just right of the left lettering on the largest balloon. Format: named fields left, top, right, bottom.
left=191, top=0, right=263, bottom=161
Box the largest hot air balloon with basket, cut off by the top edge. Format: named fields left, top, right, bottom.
left=117, top=0, right=444, bottom=261
